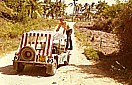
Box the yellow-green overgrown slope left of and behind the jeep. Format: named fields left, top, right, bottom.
left=0, top=0, right=58, bottom=53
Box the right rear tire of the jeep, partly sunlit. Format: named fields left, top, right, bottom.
left=46, top=60, right=57, bottom=76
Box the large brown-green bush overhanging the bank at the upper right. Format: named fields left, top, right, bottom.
left=93, top=0, right=132, bottom=52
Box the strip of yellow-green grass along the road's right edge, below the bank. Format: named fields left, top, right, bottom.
left=75, top=23, right=105, bottom=61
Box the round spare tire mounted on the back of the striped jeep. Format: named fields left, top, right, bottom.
left=20, top=46, right=36, bottom=61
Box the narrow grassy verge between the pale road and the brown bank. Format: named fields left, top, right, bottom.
left=75, top=23, right=99, bottom=61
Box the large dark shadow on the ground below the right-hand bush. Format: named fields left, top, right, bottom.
left=72, top=51, right=132, bottom=85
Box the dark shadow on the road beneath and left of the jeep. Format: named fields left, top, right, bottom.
left=0, top=65, right=49, bottom=77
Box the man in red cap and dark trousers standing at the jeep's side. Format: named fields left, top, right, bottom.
left=56, top=18, right=73, bottom=50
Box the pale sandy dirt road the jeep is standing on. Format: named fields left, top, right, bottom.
left=0, top=23, right=122, bottom=85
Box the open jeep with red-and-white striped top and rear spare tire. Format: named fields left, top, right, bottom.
left=13, top=31, right=70, bottom=75
